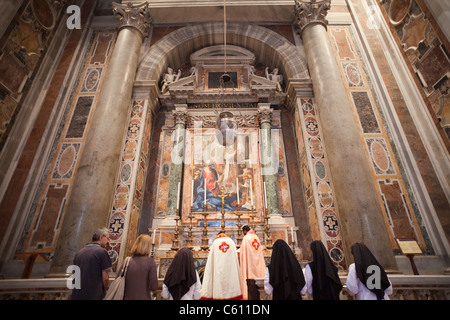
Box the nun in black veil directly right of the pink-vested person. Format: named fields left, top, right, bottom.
left=264, top=239, right=306, bottom=300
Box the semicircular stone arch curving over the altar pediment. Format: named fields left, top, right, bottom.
left=136, top=23, right=310, bottom=85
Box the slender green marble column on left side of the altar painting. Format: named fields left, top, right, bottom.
left=166, top=105, right=188, bottom=217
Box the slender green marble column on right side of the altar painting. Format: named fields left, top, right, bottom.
left=258, top=103, right=280, bottom=215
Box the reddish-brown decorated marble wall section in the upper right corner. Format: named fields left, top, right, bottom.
left=380, top=0, right=450, bottom=138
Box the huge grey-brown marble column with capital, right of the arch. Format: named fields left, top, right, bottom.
left=294, top=0, right=398, bottom=270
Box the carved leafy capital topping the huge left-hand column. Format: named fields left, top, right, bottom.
left=112, top=2, right=152, bottom=37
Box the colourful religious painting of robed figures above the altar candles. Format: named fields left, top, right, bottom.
left=191, top=133, right=255, bottom=213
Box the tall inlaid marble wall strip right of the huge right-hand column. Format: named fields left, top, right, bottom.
left=329, top=26, right=427, bottom=249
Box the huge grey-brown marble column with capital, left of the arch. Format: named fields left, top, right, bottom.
left=50, top=3, right=150, bottom=275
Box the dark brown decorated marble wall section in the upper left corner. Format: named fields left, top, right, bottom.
left=0, top=0, right=65, bottom=146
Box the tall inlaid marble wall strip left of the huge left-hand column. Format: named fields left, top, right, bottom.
left=17, top=31, right=118, bottom=253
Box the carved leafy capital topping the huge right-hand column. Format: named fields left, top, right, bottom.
left=294, top=0, right=331, bottom=34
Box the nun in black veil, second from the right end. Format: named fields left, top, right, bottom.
left=305, top=240, right=342, bottom=300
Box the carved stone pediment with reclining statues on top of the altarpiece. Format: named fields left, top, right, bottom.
left=159, top=46, right=286, bottom=110
